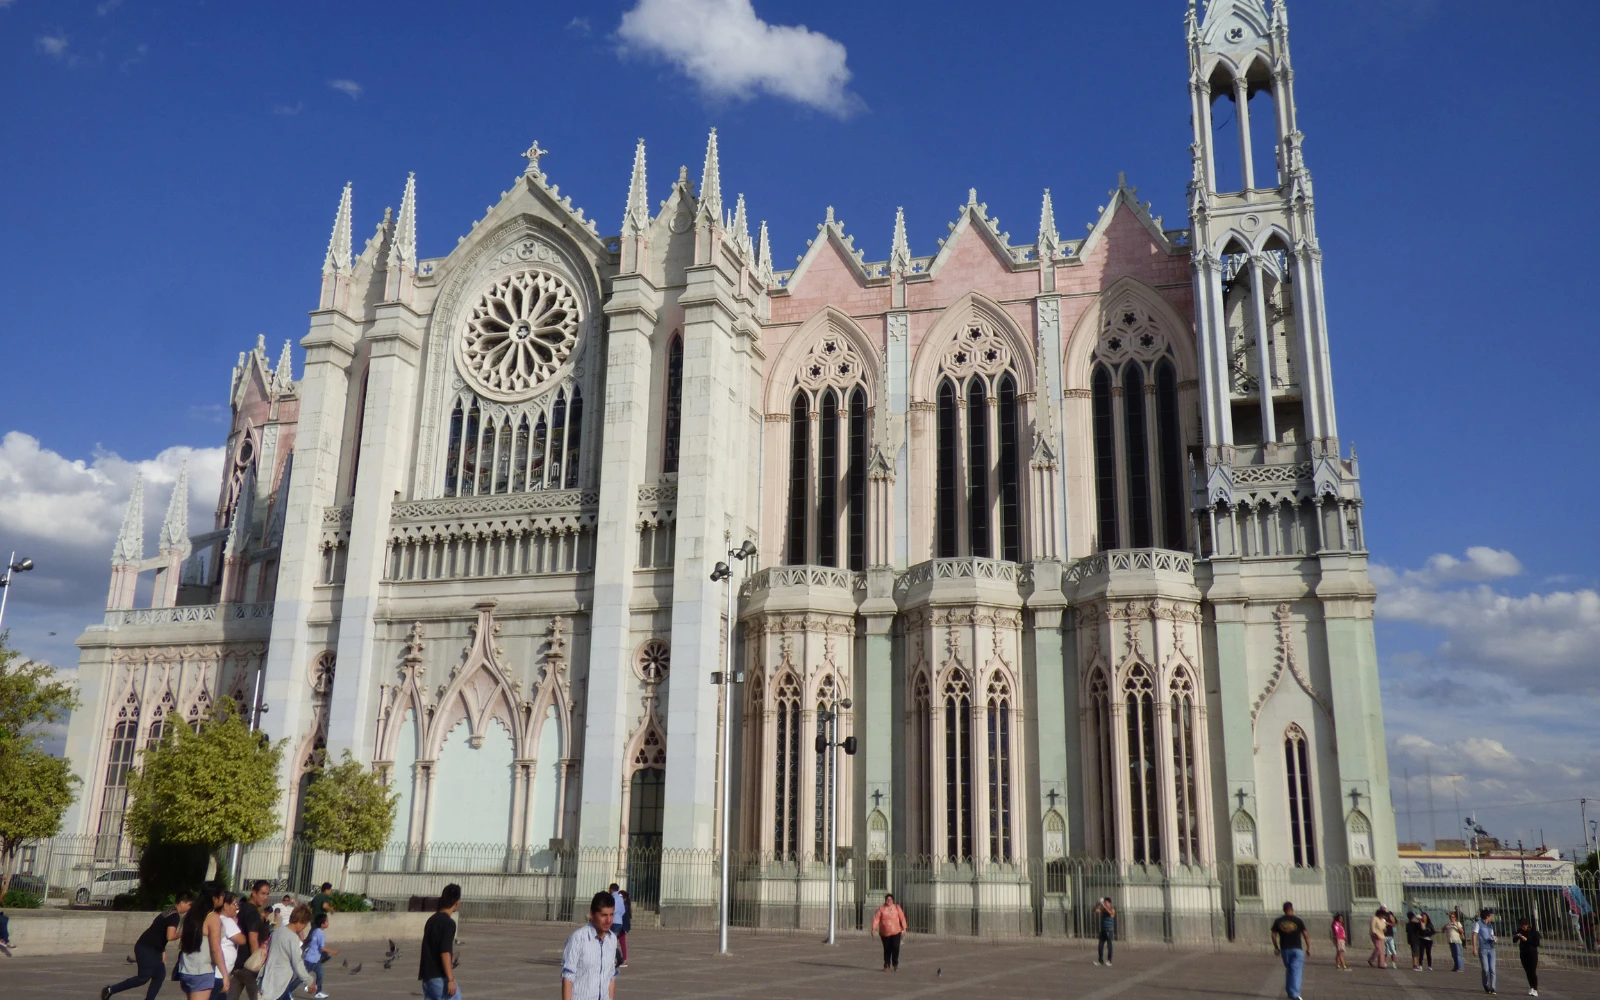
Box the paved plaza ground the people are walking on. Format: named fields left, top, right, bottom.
left=0, top=917, right=1600, bottom=1000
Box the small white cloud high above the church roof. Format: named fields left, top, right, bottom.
left=616, top=0, right=861, bottom=117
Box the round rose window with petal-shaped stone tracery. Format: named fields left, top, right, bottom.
left=458, top=270, right=582, bottom=400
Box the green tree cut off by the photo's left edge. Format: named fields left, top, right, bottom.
left=0, top=632, right=78, bottom=898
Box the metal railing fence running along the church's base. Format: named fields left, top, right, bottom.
left=14, top=837, right=1600, bottom=968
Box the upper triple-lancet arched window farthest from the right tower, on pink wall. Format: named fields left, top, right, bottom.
left=784, top=333, right=872, bottom=570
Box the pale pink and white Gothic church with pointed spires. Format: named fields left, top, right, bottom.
left=67, top=0, right=1397, bottom=921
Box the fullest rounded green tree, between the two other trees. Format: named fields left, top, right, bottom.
left=126, top=698, right=288, bottom=899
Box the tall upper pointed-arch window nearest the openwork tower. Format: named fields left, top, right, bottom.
left=1090, top=301, right=1189, bottom=550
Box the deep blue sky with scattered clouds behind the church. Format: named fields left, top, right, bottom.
left=0, top=0, right=1600, bottom=845
